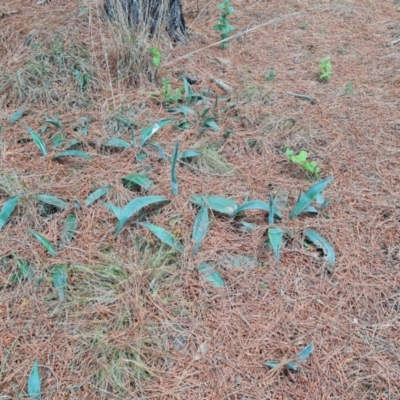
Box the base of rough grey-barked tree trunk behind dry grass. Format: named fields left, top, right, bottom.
left=104, top=0, right=187, bottom=42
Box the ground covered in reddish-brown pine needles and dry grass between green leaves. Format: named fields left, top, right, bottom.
left=0, top=0, right=400, bottom=400
